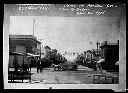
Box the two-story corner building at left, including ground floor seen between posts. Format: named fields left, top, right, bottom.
left=9, top=34, right=41, bottom=67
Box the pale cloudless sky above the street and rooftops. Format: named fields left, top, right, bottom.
left=9, top=6, right=119, bottom=53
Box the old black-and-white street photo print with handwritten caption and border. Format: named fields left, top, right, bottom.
left=3, top=4, right=126, bottom=90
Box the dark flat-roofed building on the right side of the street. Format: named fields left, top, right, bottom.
left=100, top=40, right=119, bottom=70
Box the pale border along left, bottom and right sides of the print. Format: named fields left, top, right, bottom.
left=3, top=5, right=126, bottom=91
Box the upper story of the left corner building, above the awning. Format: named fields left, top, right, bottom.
left=9, top=35, right=41, bottom=54
